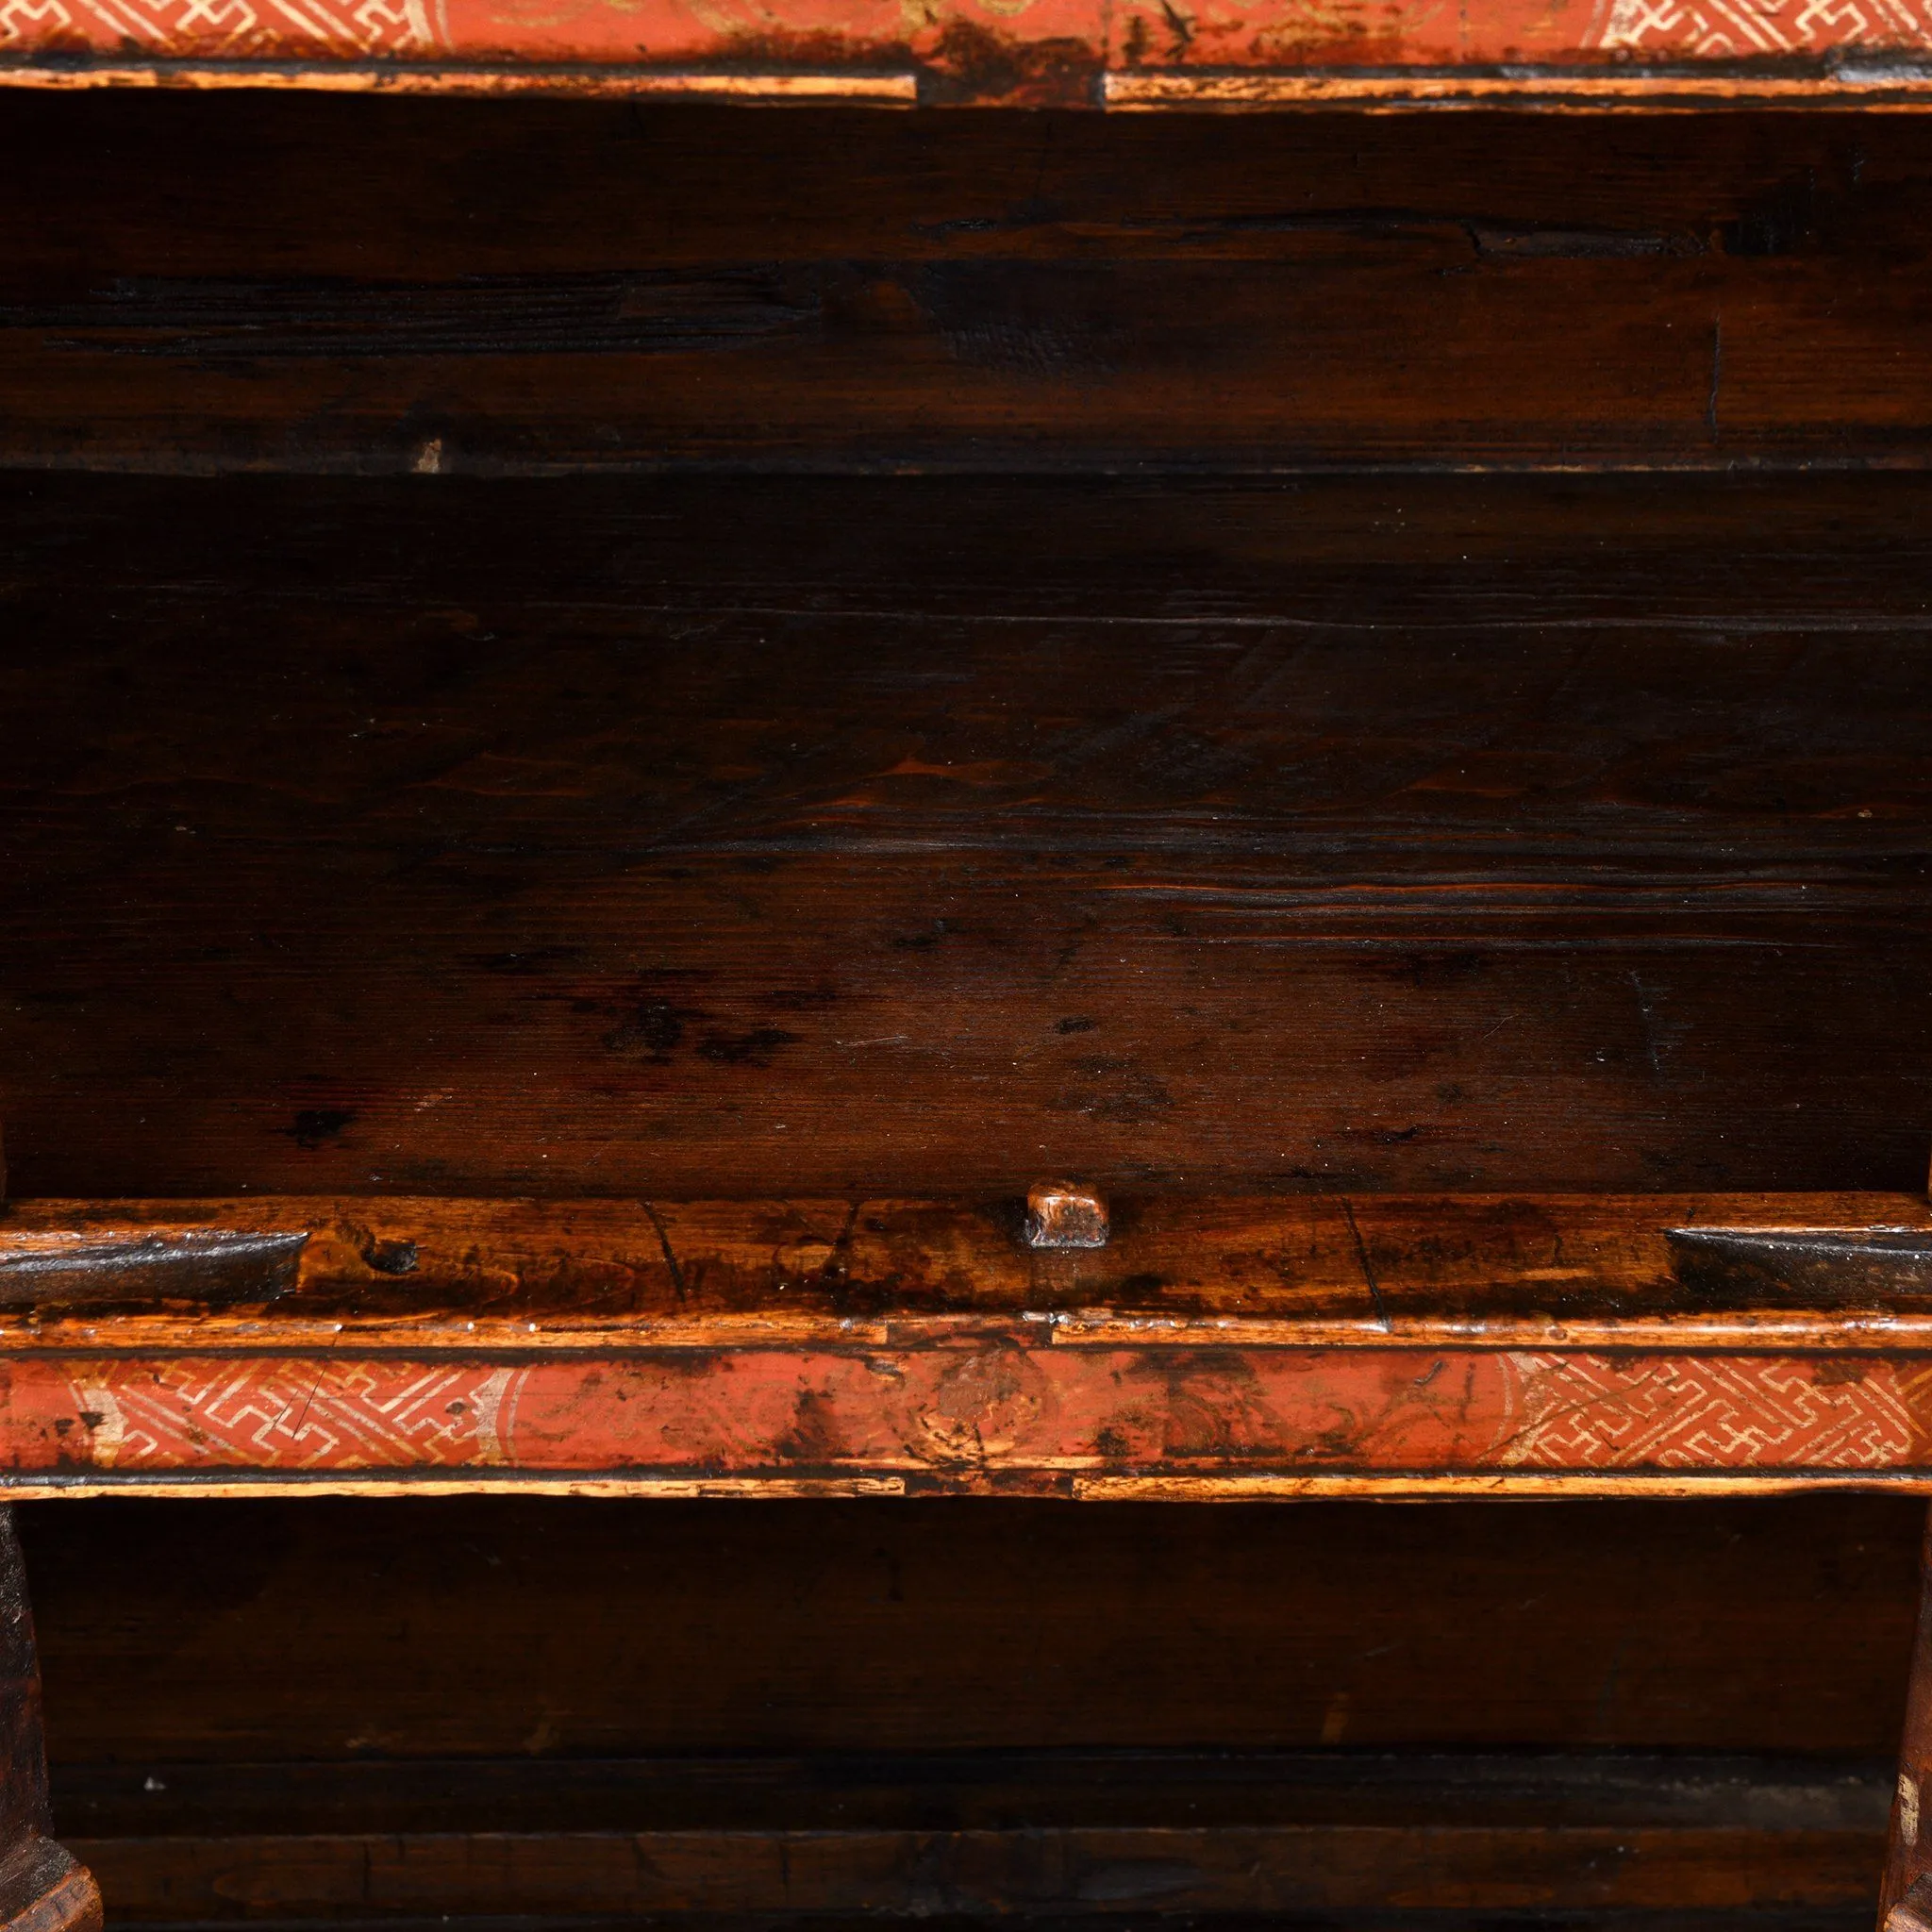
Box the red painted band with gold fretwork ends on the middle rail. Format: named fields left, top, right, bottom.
left=0, top=1335, right=1932, bottom=1490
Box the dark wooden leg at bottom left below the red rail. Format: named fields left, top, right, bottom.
left=0, top=1507, right=100, bottom=1932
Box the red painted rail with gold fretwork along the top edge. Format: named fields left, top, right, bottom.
left=0, top=0, right=1932, bottom=110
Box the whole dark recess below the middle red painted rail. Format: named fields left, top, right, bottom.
left=8, top=1497, right=1919, bottom=1932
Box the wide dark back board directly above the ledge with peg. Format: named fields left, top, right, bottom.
left=0, top=477, right=1932, bottom=1196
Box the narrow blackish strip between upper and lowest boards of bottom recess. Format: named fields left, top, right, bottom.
left=42, top=1746, right=1893, bottom=1845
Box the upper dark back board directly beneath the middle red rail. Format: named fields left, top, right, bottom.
left=22, top=1497, right=1923, bottom=1769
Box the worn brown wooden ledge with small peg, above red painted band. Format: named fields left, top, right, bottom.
left=0, top=1192, right=1932, bottom=1357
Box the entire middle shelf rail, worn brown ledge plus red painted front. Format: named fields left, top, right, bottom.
left=0, top=1194, right=1932, bottom=1499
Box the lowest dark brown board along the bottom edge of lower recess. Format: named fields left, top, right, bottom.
left=45, top=1824, right=1873, bottom=1923
